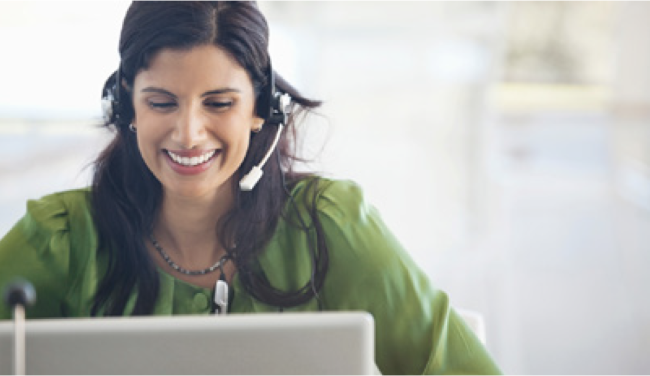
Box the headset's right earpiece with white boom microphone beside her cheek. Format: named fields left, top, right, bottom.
left=239, top=64, right=291, bottom=191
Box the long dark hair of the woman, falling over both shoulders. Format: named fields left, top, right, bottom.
left=92, top=1, right=328, bottom=315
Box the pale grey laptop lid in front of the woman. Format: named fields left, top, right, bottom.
left=0, top=312, right=377, bottom=375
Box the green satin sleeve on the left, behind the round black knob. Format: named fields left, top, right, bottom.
left=0, top=190, right=95, bottom=319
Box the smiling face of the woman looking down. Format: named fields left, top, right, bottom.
left=132, top=45, right=263, bottom=198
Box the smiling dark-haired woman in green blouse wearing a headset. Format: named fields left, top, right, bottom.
left=0, top=2, right=498, bottom=374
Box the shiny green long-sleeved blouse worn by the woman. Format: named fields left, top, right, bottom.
left=0, top=180, right=500, bottom=374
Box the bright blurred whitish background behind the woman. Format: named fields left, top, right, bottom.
left=0, top=1, right=650, bottom=374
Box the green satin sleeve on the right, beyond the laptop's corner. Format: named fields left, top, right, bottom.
left=296, top=181, right=500, bottom=374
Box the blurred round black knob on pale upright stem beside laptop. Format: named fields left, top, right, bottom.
left=4, top=280, right=36, bottom=375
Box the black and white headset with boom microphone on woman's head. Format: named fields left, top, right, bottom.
left=102, top=58, right=291, bottom=191
